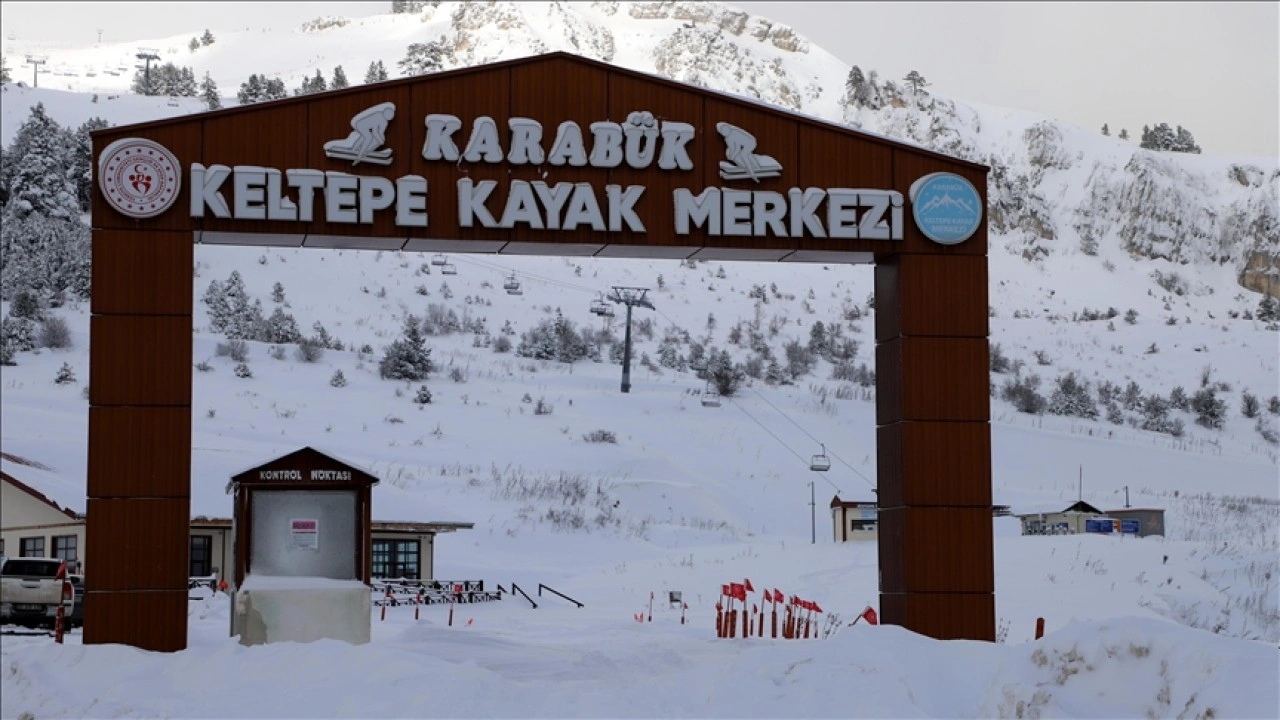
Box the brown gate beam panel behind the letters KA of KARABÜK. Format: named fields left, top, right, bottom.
left=406, top=69, right=511, bottom=245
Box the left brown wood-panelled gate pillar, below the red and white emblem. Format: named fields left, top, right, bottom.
left=84, top=228, right=193, bottom=651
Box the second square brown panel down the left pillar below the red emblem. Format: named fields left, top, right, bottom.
left=88, top=315, right=192, bottom=406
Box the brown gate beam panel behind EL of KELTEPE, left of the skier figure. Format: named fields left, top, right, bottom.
left=199, top=102, right=309, bottom=233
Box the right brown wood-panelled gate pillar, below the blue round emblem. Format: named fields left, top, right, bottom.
left=876, top=249, right=996, bottom=641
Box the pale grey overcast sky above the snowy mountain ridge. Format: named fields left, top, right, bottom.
left=0, top=0, right=1280, bottom=155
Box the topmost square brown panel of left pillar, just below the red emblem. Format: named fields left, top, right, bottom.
left=91, top=229, right=195, bottom=315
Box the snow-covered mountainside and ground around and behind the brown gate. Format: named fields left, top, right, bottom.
left=0, top=3, right=1280, bottom=717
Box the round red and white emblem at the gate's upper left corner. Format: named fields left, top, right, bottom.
left=97, top=137, right=182, bottom=218
